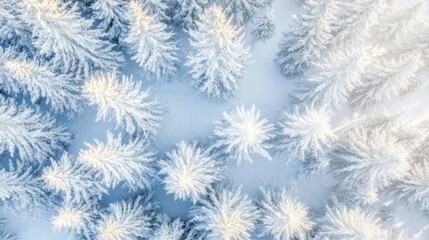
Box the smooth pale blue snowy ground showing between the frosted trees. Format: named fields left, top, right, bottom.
left=0, top=0, right=429, bottom=240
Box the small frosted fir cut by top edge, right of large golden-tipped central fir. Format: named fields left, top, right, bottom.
left=222, top=0, right=266, bottom=26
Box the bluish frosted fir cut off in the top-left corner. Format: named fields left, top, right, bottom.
left=0, top=0, right=33, bottom=52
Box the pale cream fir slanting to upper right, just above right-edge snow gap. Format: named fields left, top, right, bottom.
left=351, top=52, right=424, bottom=110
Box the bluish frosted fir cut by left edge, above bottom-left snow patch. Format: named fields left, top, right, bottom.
left=0, top=161, right=52, bottom=215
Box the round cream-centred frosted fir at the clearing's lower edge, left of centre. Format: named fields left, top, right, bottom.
left=159, top=141, right=222, bottom=204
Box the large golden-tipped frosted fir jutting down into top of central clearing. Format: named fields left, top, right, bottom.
left=186, top=5, right=251, bottom=99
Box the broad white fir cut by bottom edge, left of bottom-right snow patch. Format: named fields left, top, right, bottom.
left=315, top=206, right=390, bottom=240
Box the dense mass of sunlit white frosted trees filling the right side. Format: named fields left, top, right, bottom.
left=270, top=0, right=429, bottom=239
